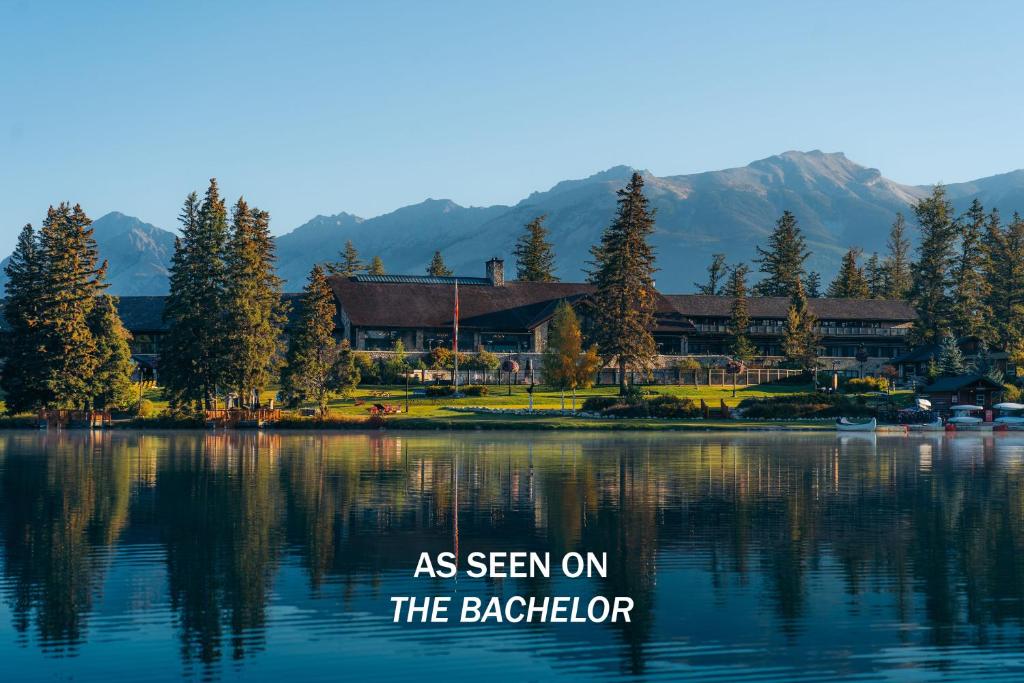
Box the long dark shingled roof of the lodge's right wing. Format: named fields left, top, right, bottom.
left=665, top=294, right=916, bottom=323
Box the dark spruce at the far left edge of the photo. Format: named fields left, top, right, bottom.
left=0, top=224, right=50, bottom=415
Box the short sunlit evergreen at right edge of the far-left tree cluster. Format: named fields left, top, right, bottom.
left=89, top=294, right=135, bottom=410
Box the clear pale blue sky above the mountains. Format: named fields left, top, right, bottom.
left=0, top=0, right=1024, bottom=254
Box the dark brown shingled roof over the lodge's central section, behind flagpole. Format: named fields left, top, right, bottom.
left=329, top=275, right=692, bottom=332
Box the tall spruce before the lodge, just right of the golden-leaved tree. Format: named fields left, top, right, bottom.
left=590, top=173, right=657, bottom=394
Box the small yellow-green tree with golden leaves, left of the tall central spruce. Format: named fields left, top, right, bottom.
left=541, top=301, right=601, bottom=413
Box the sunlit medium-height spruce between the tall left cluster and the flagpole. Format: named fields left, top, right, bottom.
left=281, top=265, right=337, bottom=417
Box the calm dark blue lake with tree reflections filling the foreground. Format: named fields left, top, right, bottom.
left=0, top=431, right=1024, bottom=683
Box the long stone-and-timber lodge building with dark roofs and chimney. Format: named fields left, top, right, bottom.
left=119, top=258, right=914, bottom=374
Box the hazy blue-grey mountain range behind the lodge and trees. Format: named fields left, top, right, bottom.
left=8, top=151, right=1024, bottom=295
